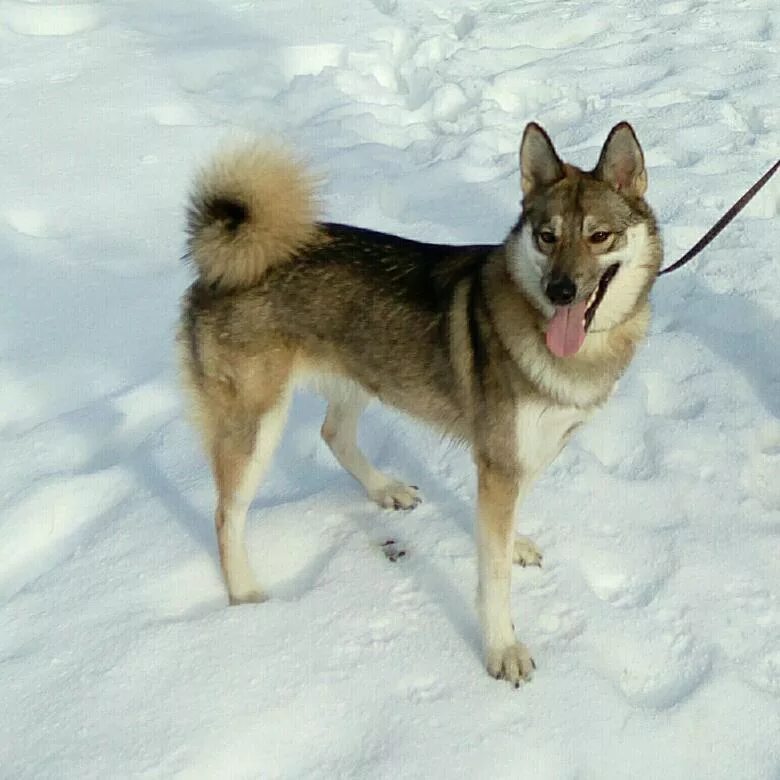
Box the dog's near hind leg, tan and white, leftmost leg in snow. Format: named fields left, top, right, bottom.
left=212, top=390, right=289, bottom=604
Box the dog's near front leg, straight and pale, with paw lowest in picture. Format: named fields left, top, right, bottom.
left=477, top=458, right=535, bottom=687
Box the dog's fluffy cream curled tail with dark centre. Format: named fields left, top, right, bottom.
left=187, top=143, right=317, bottom=290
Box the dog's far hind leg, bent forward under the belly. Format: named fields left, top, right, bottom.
left=322, top=385, right=421, bottom=509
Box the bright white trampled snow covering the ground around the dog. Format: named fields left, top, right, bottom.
left=0, top=0, right=780, bottom=780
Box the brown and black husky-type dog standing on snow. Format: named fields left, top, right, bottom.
left=178, top=122, right=661, bottom=686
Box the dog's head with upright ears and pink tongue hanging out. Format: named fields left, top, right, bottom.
left=507, top=122, right=661, bottom=357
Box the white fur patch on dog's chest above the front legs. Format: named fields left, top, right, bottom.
left=515, top=401, right=589, bottom=476
